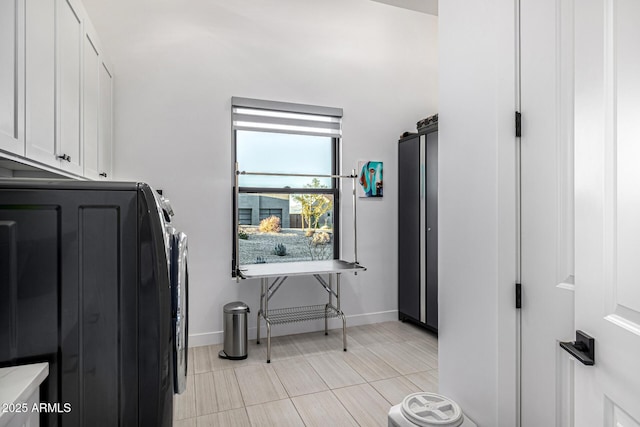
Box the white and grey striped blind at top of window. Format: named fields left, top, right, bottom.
left=231, top=97, right=342, bottom=138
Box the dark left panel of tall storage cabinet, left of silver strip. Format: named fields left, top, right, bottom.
left=398, top=138, right=421, bottom=320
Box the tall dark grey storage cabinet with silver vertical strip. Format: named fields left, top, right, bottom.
left=398, top=124, right=438, bottom=332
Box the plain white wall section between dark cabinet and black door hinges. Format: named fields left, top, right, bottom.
left=438, top=0, right=516, bottom=427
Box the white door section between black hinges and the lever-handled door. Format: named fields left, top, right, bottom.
left=520, top=0, right=575, bottom=427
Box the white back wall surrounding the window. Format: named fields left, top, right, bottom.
left=84, top=0, right=437, bottom=344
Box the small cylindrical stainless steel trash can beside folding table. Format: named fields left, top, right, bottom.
left=218, top=301, right=249, bottom=360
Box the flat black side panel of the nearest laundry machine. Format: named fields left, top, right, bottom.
left=0, top=189, right=139, bottom=427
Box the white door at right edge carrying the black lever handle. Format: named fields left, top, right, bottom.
left=575, top=0, right=640, bottom=427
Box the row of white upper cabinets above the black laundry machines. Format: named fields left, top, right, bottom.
left=0, top=0, right=113, bottom=179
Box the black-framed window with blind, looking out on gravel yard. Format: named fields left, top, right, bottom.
left=232, top=98, right=342, bottom=272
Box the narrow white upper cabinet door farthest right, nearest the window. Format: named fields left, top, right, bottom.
left=98, top=63, right=113, bottom=178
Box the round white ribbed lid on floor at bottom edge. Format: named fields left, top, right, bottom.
left=401, top=392, right=464, bottom=427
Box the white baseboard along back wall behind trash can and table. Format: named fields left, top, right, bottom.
left=189, top=310, right=398, bottom=347
